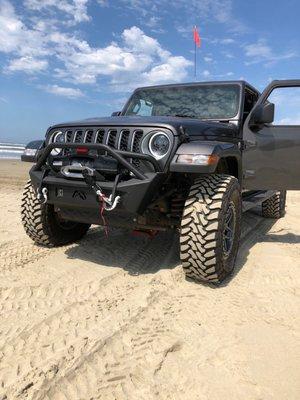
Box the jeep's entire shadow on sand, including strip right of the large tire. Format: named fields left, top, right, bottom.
left=65, top=211, right=300, bottom=288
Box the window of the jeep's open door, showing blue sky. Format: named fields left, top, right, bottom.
left=267, top=87, right=300, bottom=126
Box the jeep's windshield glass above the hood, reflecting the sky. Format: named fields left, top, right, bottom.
left=123, top=85, right=240, bottom=120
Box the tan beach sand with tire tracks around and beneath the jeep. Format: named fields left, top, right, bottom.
left=0, top=161, right=300, bottom=400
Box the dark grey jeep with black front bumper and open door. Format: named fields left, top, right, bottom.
left=22, top=80, right=300, bottom=283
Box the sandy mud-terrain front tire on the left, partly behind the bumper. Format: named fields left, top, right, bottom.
left=21, top=181, right=90, bottom=247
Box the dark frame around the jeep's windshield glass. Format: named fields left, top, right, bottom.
left=121, top=81, right=245, bottom=122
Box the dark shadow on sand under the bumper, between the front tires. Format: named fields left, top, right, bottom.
left=65, top=228, right=180, bottom=275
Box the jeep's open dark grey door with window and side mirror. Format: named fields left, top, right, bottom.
left=242, top=80, right=300, bottom=190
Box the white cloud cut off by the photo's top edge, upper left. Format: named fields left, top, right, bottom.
left=24, top=0, right=90, bottom=23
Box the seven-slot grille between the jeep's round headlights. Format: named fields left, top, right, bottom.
left=60, top=128, right=144, bottom=153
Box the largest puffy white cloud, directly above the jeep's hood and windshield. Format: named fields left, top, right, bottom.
left=57, top=26, right=191, bottom=90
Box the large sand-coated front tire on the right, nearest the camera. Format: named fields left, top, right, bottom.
left=180, top=175, right=242, bottom=283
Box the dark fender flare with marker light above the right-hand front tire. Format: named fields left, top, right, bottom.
left=170, top=140, right=242, bottom=180
